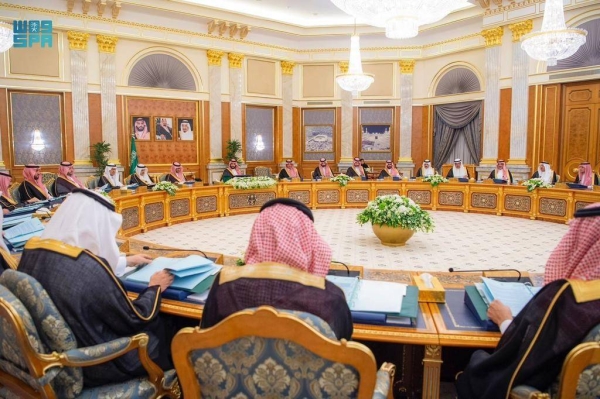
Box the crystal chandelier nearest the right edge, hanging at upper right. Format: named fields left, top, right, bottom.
left=521, top=0, right=587, bottom=66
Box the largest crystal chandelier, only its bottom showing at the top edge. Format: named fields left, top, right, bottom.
left=331, top=0, right=467, bottom=39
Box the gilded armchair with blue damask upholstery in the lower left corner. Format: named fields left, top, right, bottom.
left=0, top=270, right=179, bottom=398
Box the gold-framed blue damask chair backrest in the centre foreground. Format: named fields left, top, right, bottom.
left=171, top=306, right=377, bottom=398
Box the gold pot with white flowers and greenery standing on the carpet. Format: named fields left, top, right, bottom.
left=356, top=195, right=434, bottom=247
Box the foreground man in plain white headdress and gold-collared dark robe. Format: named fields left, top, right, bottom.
left=18, top=189, right=176, bottom=387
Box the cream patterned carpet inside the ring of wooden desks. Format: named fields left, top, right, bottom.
left=135, top=209, right=568, bottom=273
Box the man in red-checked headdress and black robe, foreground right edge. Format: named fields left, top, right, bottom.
left=456, top=203, right=600, bottom=399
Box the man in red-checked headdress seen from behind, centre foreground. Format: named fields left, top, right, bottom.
left=201, top=198, right=352, bottom=339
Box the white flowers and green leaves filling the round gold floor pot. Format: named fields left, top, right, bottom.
left=356, top=195, right=434, bottom=233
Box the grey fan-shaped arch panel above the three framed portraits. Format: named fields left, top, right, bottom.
left=128, top=54, right=196, bottom=91
